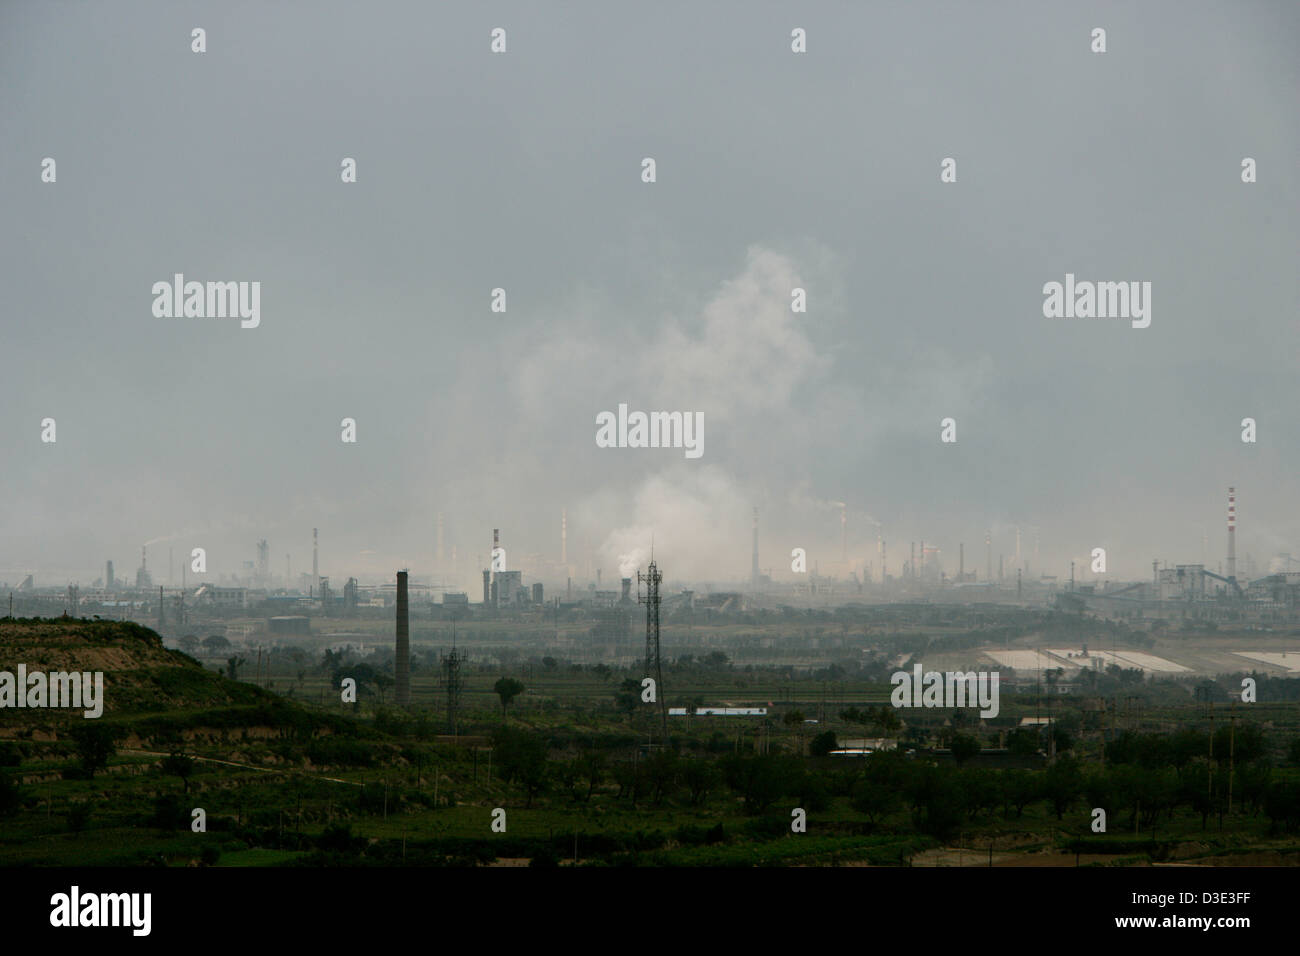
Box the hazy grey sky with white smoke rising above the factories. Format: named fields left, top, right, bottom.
left=0, top=0, right=1300, bottom=585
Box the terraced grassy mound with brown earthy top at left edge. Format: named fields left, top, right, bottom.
left=0, top=618, right=330, bottom=737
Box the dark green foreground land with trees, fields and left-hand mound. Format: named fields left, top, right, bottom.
left=0, top=622, right=1300, bottom=866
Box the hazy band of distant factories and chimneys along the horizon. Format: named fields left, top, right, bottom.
left=0, top=485, right=1300, bottom=609
